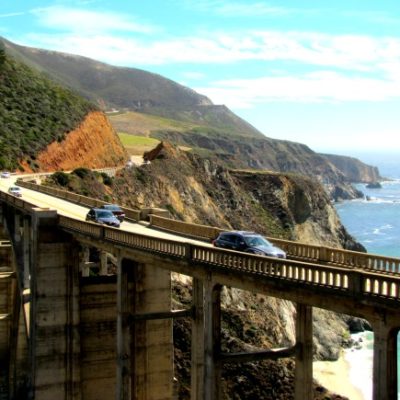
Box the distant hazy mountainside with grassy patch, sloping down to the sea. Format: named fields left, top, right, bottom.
left=1, top=39, right=382, bottom=194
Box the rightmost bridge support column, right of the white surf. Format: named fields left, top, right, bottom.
left=372, top=321, right=398, bottom=400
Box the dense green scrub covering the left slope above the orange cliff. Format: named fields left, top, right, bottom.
left=0, top=50, right=94, bottom=170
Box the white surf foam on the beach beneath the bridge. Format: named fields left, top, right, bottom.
left=345, top=332, right=373, bottom=400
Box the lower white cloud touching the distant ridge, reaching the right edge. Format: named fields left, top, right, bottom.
left=195, top=71, right=400, bottom=109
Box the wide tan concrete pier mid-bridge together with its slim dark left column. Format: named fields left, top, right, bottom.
left=116, top=258, right=173, bottom=400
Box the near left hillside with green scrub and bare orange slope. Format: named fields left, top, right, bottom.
left=0, top=43, right=127, bottom=171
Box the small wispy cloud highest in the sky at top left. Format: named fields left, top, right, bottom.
left=31, top=6, right=154, bottom=35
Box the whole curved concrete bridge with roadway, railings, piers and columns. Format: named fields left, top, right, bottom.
left=0, top=178, right=400, bottom=400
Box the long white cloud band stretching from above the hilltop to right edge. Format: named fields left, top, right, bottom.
left=25, top=29, right=400, bottom=72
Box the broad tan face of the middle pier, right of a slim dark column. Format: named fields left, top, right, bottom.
left=126, top=264, right=174, bottom=400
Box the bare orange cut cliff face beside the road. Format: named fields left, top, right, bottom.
left=21, top=111, right=128, bottom=172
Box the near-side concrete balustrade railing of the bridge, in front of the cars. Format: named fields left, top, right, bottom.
left=59, top=216, right=400, bottom=302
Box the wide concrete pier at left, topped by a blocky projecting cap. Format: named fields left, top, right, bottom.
left=27, top=209, right=81, bottom=400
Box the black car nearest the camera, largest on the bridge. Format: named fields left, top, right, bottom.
left=213, top=231, right=286, bottom=258
